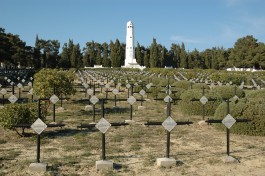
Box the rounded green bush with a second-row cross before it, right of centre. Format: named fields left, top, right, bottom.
left=180, top=89, right=221, bottom=115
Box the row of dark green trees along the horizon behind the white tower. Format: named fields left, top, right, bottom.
left=0, top=28, right=265, bottom=70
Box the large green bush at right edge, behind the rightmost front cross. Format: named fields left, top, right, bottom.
left=214, top=90, right=265, bottom=136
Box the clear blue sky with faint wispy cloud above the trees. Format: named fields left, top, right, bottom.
left=0, top=0, right=265, bottom=51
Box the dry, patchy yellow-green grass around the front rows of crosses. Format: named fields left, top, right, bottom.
left=0, top=93, right=265, bottom=176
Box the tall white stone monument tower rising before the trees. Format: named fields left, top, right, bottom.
left=123, top=21, right=145, bottom=70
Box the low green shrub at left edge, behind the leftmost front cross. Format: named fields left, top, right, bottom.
left=0, top=103, right=45, bottom=129
